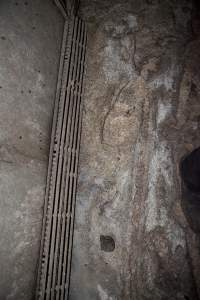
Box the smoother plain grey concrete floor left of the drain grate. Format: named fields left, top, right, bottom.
left=0, top=0, right=63, bottom=300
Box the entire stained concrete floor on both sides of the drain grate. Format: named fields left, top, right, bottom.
left=0, top=0, right=200, bottom=300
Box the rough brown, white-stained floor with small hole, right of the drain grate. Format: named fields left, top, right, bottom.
left=70, top=0, right=200, bottom=300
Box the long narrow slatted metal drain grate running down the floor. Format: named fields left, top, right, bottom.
left=36, top=17, right=87, bottom=300
